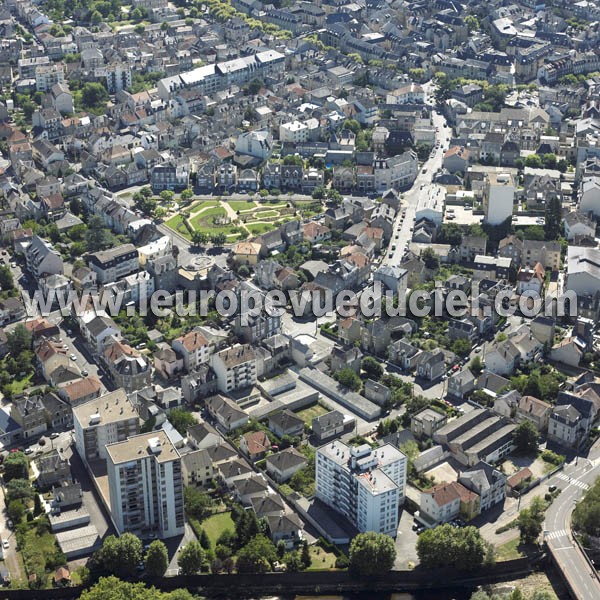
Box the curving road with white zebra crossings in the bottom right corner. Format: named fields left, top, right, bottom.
left=544, top=444, right=600, bottom=600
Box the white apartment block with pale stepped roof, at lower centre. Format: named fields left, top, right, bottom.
left=315, top=440, right=407, bottom=537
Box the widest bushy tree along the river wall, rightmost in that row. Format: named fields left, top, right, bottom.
left=417, top=523, right=493, bottom=571
